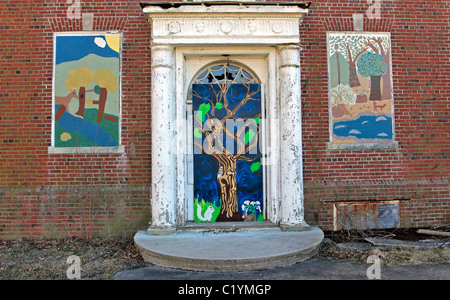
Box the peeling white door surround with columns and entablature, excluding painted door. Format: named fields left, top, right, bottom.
left=142, top=2, right=309, bottom=235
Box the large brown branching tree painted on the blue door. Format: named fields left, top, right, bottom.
left=192, top=83, right=261, bottom=221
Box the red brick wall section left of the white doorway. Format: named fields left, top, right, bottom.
left=0, top=0, right=151, bottom=238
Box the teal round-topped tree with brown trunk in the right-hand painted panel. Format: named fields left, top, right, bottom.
left=356, top=52, right=388, bottom=101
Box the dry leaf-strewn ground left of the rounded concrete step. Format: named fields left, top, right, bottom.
left=0, top=235, right=145, bottom=280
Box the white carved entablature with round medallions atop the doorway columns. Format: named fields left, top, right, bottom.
left=142, top=1, right=308, bottom=45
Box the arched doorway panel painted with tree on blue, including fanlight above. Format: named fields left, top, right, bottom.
left=192, top=65, right=264, bottom=222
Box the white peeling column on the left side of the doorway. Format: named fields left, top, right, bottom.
left=148, top=45, right=177, bottom=235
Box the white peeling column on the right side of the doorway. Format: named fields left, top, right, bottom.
left=277, top=44, right=309, bottom=231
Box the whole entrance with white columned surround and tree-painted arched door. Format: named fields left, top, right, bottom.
left=143, top=2, right=309, bottom=235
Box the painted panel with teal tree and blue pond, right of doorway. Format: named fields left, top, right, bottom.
left=327, top=32, right=394, bottom=144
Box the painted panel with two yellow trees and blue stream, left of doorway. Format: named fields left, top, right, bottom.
left=53, top=33, right=121, bottom=148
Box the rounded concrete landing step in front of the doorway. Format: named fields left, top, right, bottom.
left=134, top=226, right=324, bottom=271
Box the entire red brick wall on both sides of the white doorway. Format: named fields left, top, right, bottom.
left=0, top=0, right=450, bottom=238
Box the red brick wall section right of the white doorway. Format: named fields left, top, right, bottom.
left=301, top=0, right=450, bottom=229
